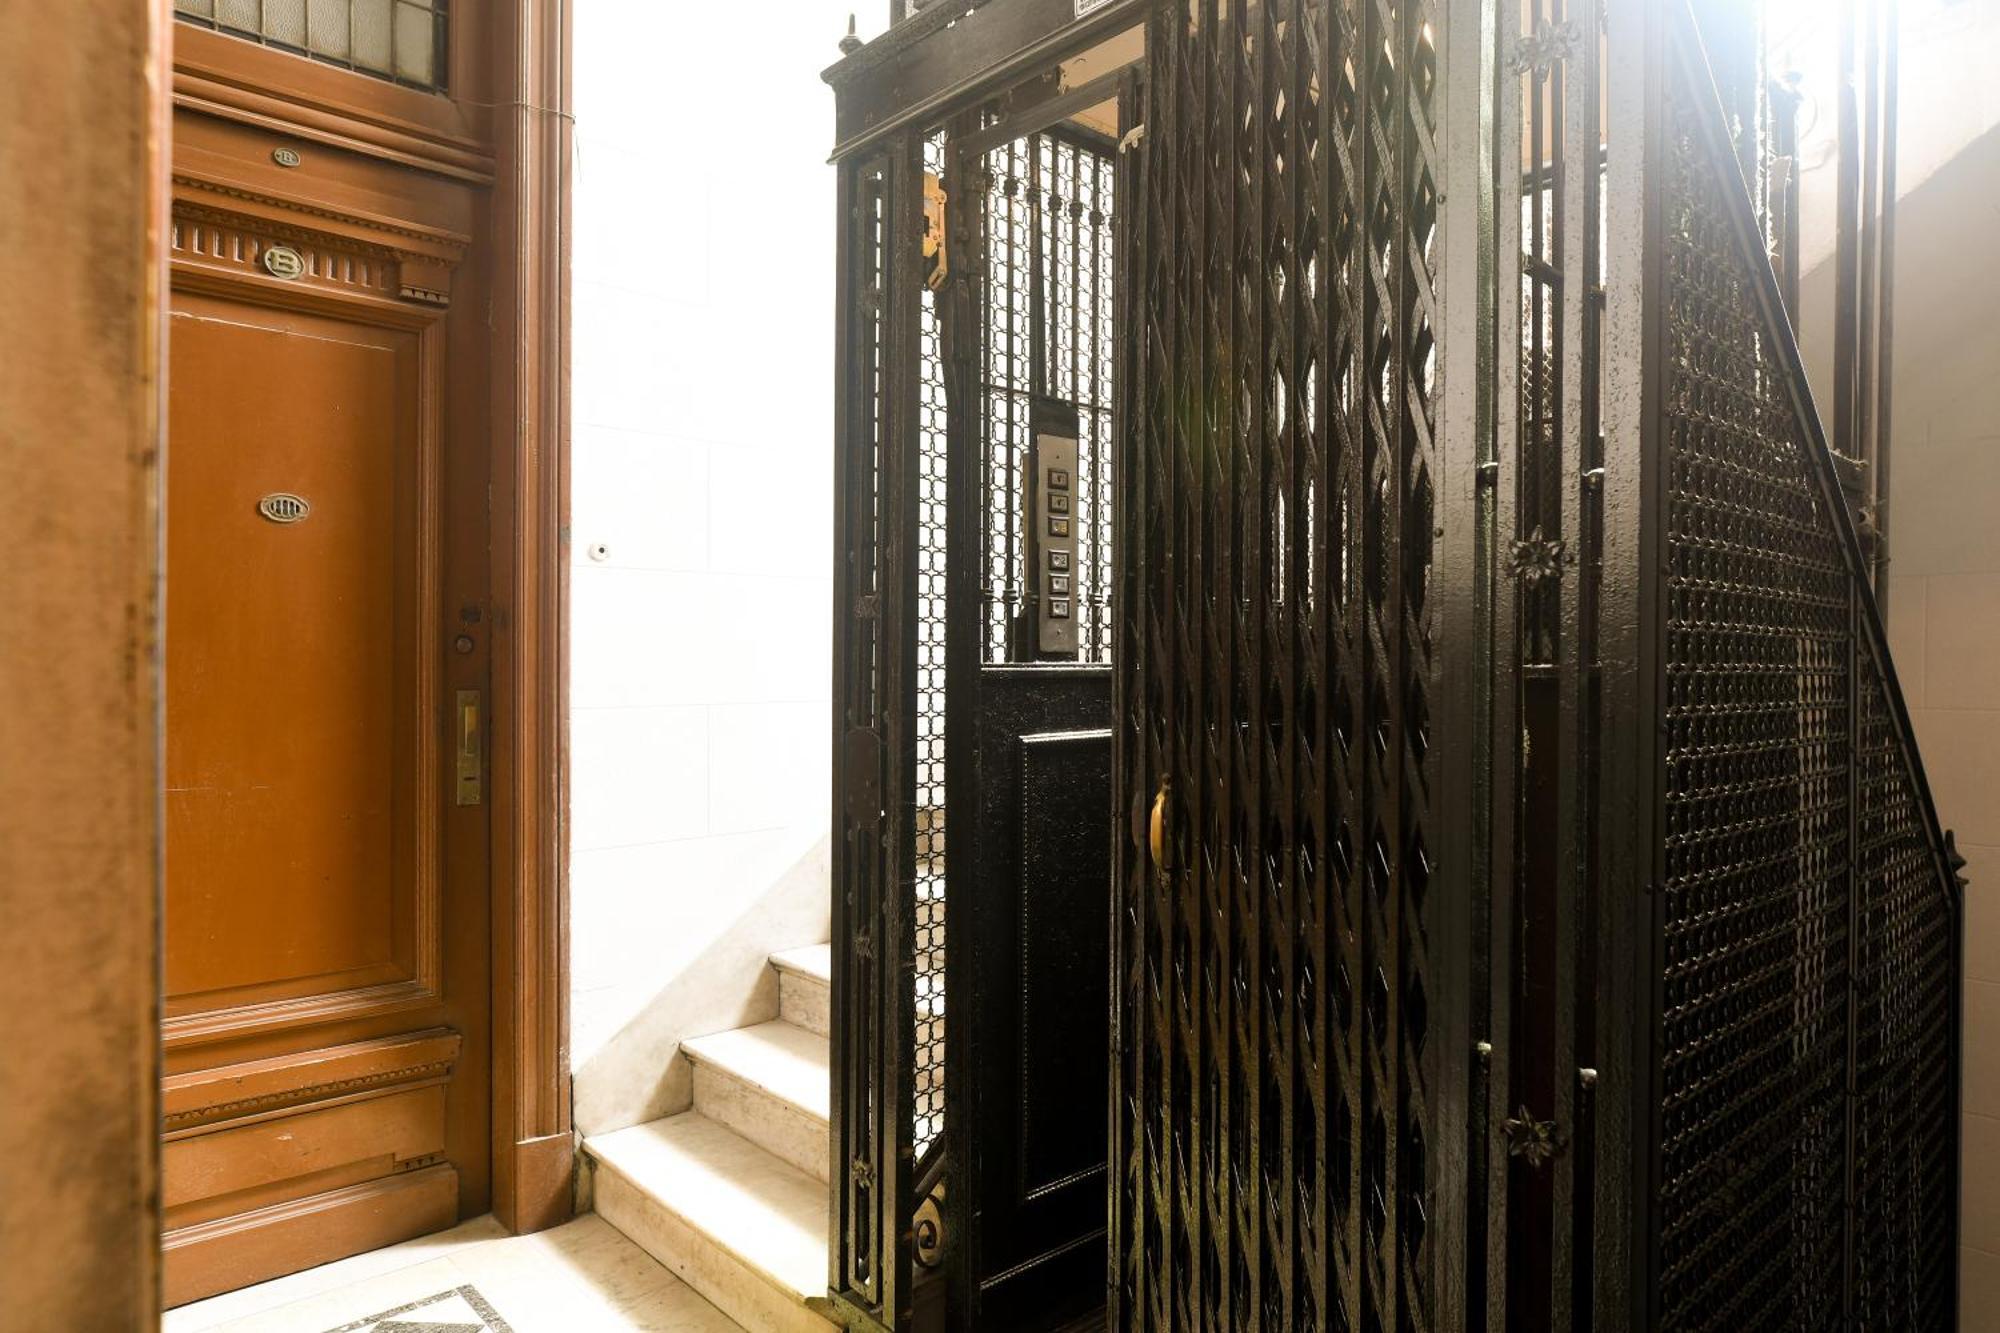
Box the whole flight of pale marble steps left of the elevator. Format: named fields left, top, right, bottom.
left=584, top=945, right=836, bottom=1333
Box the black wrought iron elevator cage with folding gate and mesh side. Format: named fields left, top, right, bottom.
left=830, top=0, right=1962, bottom=1333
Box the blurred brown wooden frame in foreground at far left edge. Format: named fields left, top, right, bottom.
left=0, top=0, right=170, bottom=1329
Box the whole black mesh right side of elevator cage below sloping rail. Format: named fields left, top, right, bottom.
left=1654, top=7, right=1958, bottom=1333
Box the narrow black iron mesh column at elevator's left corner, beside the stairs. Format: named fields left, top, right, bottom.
left=828, top=140, right=922, bottom=1327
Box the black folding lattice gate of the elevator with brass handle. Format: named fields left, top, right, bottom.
left=1112, top=0, right=1440, bottom=1333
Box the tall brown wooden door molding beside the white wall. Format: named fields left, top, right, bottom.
left=488, top=0, right=576, bottom=1231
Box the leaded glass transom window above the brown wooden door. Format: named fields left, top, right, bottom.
left=174, top=0, right=446, bottom=92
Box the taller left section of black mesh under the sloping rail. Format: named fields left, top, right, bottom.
left=1660, top=70, right=1854, bottom=1329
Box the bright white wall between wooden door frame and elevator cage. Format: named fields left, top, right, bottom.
left=570, top=0, right=876, bottom=1133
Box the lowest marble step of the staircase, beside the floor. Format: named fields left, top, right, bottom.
left=584, top=1111, right=836, bottom=1333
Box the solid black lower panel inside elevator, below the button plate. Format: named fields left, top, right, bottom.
left=954, top=680, right=1112, bottom=1329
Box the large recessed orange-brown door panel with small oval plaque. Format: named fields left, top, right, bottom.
left=166, top=296, right=436, bottom=1017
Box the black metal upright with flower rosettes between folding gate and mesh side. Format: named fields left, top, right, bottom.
left=1488, top=0, right=1624, bottom=1331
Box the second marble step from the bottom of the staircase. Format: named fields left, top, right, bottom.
left=680, top=1019, right=832, bottom=1181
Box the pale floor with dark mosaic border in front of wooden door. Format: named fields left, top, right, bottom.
left=160, top=1215, right=742, bottom=1333
